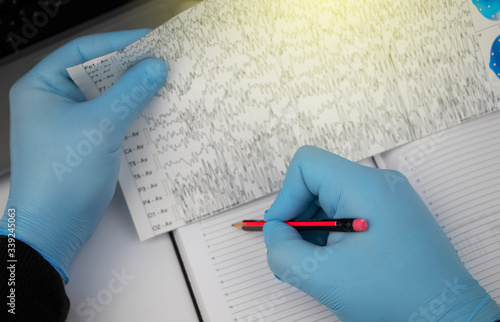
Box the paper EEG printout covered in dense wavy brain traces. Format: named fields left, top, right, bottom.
left=69, top=0, right=498, bottom=240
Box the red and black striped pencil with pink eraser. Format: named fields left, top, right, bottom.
left=233, top=218, right=368, bottom=233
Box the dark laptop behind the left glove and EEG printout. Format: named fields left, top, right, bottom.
left=0, top=0, right=200, bottom=175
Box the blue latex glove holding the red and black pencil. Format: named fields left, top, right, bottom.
left=264, top=146, right=500, bottom=322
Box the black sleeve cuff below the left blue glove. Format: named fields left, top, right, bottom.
left=0, top=235, right=69, bottom=321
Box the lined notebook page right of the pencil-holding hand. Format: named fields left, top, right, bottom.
left=376, top=113, right=500, bottom=304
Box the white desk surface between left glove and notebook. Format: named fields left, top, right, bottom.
left=0, top=175, right=198, bottom=322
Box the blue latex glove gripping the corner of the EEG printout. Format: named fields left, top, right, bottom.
left=0, top=30, right=168, bottom=282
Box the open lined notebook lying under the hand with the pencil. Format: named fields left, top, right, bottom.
left=174, top=113, right=500, bottom=322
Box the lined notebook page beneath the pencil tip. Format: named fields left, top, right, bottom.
left=174, top=195, right=339, bottom=322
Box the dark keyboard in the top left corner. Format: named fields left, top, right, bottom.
left=0, top=0, right=132, bottom=58
